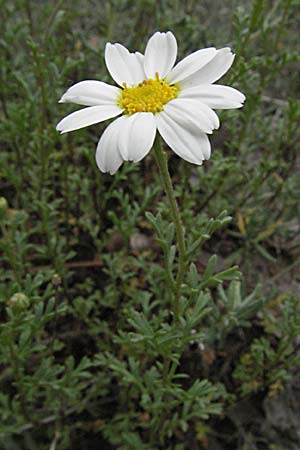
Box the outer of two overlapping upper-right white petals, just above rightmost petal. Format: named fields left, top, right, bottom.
left=182, top=47, right=235, bottom=87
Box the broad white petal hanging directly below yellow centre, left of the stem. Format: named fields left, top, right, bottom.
left=118, top=112, right=156, bottom=162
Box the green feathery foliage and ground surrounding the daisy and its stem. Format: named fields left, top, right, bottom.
left=0, top=0, right=300, bottom=450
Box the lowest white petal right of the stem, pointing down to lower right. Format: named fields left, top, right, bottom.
left=155, top=111, right=210, bottom=165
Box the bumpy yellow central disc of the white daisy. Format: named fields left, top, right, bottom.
left=118, top=72, right=179, bottom=114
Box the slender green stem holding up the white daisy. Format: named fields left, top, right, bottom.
left=153, top=136, right=186, bottom=322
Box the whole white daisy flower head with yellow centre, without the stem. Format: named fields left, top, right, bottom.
left=56, top=31, right=245, bottom=175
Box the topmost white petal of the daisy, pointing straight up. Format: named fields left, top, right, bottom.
left=144, top=31, right=177, bottom=78
